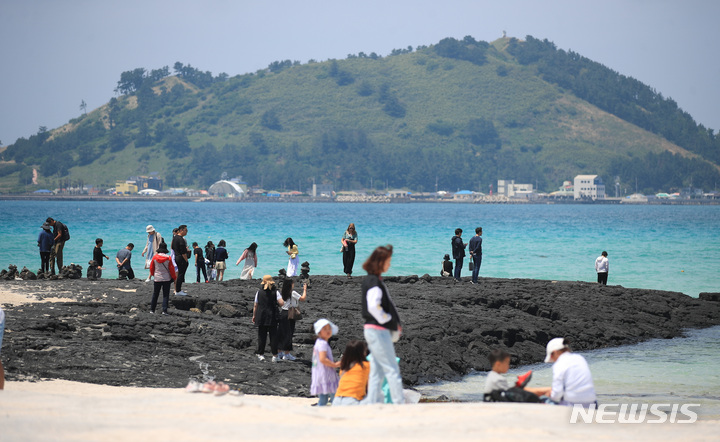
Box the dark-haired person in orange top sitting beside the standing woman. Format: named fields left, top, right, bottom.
left=333, top=340, right=370, bottom=406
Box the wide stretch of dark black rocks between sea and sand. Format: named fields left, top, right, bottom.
left=0, top=275, right=720, bottom=396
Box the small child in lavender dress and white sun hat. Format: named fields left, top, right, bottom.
left=310, top=318, right=340, bottom=407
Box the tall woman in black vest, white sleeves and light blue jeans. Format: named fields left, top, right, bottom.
left=361, top=245, right=405, bottom=404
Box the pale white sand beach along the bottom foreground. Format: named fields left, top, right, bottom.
left=0, top=380, right=720, bottom=442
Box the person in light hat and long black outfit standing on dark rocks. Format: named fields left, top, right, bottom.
left=252, top=275, right=283, bottom=362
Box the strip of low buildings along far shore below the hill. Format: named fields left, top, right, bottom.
left=25, top=175, right=720, bottom=204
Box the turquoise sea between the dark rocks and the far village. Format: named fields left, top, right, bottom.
left=0, top=201, right=720, bottom=296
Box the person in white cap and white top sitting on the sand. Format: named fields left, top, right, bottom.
left=539, top=338, right=597, bottom=407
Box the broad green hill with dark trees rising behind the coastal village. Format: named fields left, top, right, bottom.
left=0, top=37, right=720, bottom=191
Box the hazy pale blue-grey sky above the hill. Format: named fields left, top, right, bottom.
left=0, top=0, right=720, bottom=145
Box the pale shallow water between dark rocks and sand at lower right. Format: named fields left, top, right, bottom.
left=419, top=327, right=720, bottom=419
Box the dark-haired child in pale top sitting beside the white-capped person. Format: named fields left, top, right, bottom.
left=483, top=348, right=545, bottom=402
